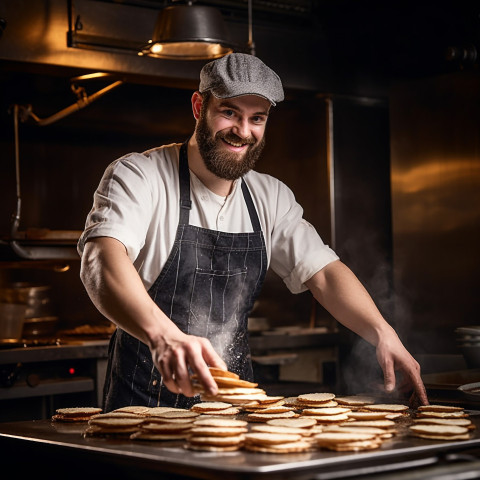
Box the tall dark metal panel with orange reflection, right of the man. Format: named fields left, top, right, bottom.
left=390, top=72, right=480, bottom=353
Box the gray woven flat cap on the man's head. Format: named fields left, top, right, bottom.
left=199, top=53, right=284, bottom=105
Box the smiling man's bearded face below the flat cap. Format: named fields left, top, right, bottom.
left=195, top=95, right=270, bottom=180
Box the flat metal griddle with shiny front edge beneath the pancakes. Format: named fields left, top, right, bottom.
left=0, top=411, right=480, bottom=480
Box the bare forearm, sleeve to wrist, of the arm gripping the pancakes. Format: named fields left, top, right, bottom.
left=80, top=238, right=176, bottom=345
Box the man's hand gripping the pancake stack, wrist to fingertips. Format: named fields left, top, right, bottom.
left=150, top=330, right=227, bottom=397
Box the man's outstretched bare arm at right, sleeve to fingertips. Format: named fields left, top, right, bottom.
left=305, top=260, right=429, bottom=405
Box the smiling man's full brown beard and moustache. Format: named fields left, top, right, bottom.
left=195, top=112, right=265, bottom=180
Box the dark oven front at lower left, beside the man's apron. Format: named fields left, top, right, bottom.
left=0, top=338, right=108, bottom=421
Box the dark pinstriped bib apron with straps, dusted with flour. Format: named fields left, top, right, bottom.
left=103, top=142, right=267, bottom=412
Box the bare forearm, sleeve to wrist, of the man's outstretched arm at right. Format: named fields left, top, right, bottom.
left=306, top=261, right=396, bottom=346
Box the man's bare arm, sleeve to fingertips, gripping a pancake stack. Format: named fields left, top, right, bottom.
left=80, top=237, right=226, bottom=396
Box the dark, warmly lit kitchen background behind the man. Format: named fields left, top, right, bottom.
left=0, top=1, right=480, bottom=478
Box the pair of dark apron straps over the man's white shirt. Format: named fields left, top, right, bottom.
left=178, top=140, right=262, bottom=232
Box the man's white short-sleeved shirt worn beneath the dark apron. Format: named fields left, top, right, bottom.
left=78, top=144, right=338, bottom=293
